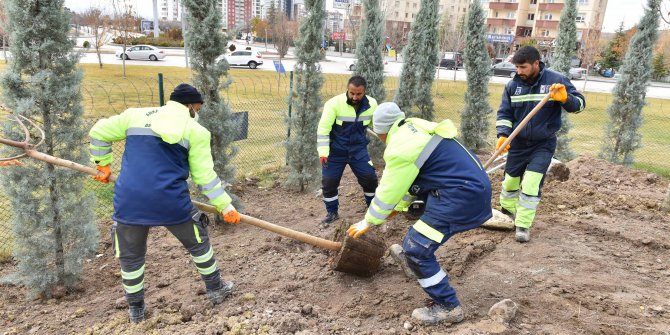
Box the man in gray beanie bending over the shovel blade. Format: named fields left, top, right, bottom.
left=347, top=102, right=492, bottom=324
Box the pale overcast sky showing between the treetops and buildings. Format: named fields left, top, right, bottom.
left=65, top=0, right=670, bottom=32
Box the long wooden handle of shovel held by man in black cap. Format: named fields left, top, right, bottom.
left=17, top=150, right=342, bottom=251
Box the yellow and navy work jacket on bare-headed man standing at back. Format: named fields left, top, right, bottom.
left=316, top=93, right=377, bottom=159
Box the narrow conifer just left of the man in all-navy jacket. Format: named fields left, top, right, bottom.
left=461, top=1, right=493, bottom=150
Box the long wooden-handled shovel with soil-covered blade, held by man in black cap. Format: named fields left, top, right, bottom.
left=0, top=118, right=386, bottom=277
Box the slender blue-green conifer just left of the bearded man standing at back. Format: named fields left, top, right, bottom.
left=285, top=0, right=326, bottom=191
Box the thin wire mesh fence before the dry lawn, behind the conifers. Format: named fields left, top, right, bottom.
left=0, top=70, right=670, bottom=259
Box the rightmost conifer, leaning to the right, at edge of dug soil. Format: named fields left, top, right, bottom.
left=600, top=0, right=661, bottom=165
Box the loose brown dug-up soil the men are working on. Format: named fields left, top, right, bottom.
left=0, top=157, right=670, bottom=334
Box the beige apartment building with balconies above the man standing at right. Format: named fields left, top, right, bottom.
left=482, top=0, right=607, bottom=60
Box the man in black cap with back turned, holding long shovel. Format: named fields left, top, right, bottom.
left=90, top=84, right=240, bottom=323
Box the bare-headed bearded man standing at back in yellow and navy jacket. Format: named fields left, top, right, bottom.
left=317, top=76, right=377, bottom=224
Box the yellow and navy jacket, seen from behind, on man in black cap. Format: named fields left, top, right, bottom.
left=89, top=101, right=231, bottom=226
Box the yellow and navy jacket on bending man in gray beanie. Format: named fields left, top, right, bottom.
left=365, top=118, right=491, bottom=229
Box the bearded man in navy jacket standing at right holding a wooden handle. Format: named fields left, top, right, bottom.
left=496, top=46, right=586, bottom=243
